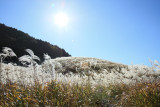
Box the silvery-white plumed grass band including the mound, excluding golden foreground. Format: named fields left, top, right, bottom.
left=1, top=57, right=160, bottom=85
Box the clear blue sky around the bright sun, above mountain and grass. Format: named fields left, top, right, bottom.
left=0, top=0, right=160, bottom=65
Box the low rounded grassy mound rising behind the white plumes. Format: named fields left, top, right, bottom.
left=51, top=57, right=128, bottom=73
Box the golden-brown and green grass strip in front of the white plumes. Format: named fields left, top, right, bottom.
left=0, top=80, right=160, bottom=107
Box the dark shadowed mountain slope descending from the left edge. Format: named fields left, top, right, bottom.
left=0, top=24, right=70, bottom=62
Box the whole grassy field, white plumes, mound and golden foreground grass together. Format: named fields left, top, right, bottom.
left=0, top=47, right=160, bottom=107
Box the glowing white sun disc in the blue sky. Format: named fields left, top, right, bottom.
left=55, top=13, right=69, bottom=27
